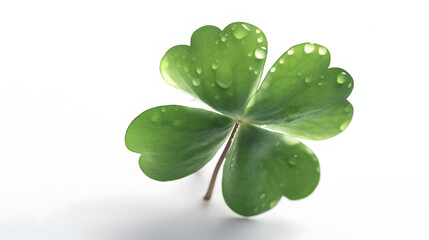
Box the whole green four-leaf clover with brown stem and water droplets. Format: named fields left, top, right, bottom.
left=125, top=22, right=353, bottom=216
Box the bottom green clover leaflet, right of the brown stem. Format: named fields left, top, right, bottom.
left=222, top=124, right=320, bottom=216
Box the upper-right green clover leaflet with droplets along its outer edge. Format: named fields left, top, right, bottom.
left=245, top=43, right=353, bottom=140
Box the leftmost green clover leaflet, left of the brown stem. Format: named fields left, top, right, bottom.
left=125, top=105, right=234, bottom=181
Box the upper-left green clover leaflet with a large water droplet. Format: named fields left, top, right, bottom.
left=160, top=23, right=267, bottom=118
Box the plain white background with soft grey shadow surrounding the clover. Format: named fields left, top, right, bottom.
left=0, top=0, right=429, bottom=240
